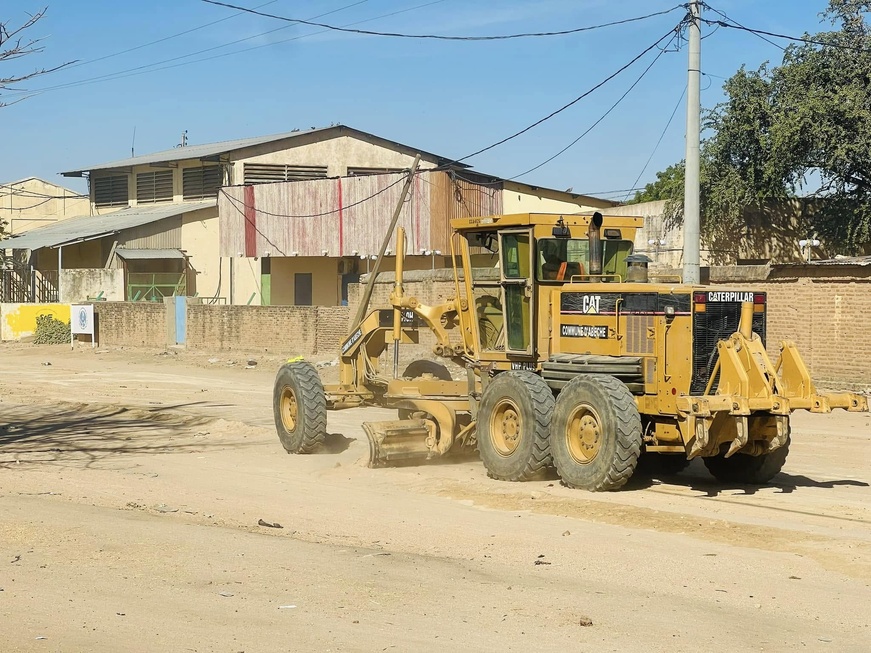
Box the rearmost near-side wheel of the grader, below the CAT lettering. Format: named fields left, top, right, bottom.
left=550, top=374, right=642, bottom=492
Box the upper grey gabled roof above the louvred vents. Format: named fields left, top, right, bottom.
left=60, top=125, right=468, bottom=177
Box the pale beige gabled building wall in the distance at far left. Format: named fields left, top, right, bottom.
left=0, top=177, right=90, bottom=235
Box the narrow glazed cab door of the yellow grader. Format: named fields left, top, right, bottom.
left=499, top=229, right=534, bottom=356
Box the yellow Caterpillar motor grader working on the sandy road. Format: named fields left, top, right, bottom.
left=274, top=213, right=868, bottom=490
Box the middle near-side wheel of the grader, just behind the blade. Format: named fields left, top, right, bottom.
left=477, top=370, right=554, bottom=481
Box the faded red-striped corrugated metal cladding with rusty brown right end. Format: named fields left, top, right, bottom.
left=218, top=172, right=502, bottom=256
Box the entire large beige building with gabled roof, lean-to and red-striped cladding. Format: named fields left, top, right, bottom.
left=2, top=125, right=614, bottom=305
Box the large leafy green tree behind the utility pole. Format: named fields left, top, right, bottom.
left=636, top=0, right=871, bottom=253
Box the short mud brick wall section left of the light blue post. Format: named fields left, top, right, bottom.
left=94, top=302, right=167, bottom=349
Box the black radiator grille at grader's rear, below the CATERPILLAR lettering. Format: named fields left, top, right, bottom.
left=690, top=302, right=765, bottom=395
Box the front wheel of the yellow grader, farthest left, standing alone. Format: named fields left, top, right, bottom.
left=272, top=362, right=327, bottom=453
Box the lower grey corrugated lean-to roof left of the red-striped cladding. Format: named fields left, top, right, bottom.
left=0, top=200, right=217, bottom=250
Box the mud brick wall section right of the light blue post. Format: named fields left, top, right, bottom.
left=187, top=304, right=318, bottom=356
